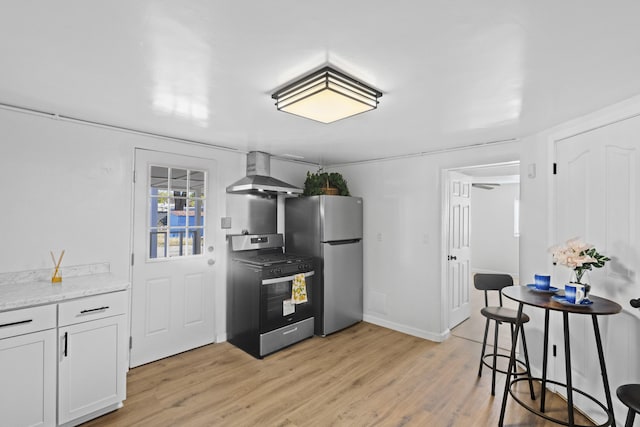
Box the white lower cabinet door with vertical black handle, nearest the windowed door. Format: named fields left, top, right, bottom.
left=58, top=315, right=128, bottom=424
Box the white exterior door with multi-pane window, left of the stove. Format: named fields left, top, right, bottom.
left=130, top=150, right=215, bottom=367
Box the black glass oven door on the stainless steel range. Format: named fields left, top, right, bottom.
left=260, top=271, right=314, bottom=333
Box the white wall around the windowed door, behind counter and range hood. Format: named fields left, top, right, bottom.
left=0, top=108, right=312, bottom=340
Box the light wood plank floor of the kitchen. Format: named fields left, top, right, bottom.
left=86, top=322, right=591, bottom=427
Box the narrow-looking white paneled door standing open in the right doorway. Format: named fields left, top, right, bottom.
left=447, top=171, right=471, bottom=328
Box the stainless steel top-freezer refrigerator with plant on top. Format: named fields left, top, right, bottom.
left=285, top=196, right=362, bottom=336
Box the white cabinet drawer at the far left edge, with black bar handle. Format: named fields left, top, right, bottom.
left=0, top=304, right=56, bottom=339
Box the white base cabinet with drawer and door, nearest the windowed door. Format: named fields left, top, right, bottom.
left=58, top=292, right=129, bottom=425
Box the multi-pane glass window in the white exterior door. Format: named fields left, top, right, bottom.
left=148, top=165, right=207, bottom=259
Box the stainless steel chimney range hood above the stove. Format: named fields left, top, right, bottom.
left=227, top=151, right=302, bottom=194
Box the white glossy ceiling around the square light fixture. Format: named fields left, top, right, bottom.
left=0, top=0, right=640, bottom=164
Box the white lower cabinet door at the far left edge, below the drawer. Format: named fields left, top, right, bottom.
left=0, top=329, right=56, bottom=427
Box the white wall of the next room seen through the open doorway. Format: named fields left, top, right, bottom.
left=471, top=184, right=520, bottom=277
